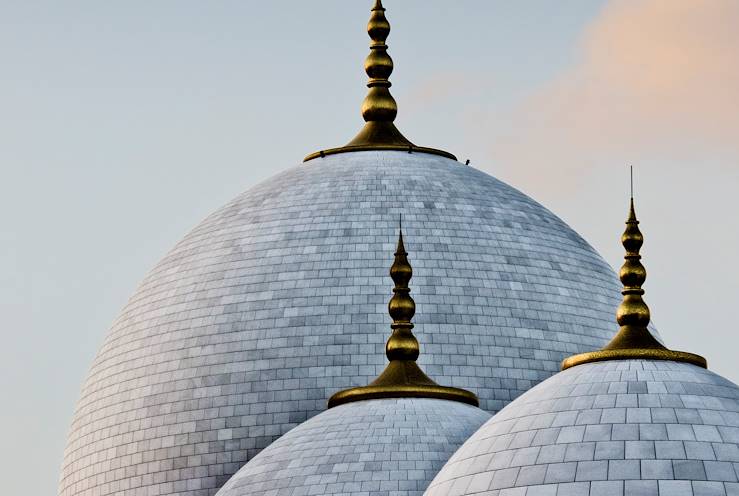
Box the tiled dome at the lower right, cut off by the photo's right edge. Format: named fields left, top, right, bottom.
left=426, top=360, right=739, bottom=496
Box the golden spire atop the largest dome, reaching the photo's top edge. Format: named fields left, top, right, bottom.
left=304, top=0, right=456, bottom=162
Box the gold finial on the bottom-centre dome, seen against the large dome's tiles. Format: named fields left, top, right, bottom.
left=328, top=223, right=479, bottom=408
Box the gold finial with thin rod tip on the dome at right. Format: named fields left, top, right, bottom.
left=562, top=175, right=708, bottom=370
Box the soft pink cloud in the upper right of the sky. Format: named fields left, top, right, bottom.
left=491, top=0, right=739, bottom=188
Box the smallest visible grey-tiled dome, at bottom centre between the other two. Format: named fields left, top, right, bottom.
left=217, top=398, right=490, bottom=496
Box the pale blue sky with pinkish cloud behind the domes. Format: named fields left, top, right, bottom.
left=0, top=0, right=739, bottom=494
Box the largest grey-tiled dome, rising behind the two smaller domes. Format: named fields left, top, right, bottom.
left=60, top=152, right=648, bottom=496
